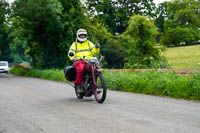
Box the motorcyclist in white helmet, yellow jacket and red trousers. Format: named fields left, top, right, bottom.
left=68, top=29, right=100, bottom=93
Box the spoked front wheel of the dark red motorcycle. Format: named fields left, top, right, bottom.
left=94, top=73, right=107, bottom=103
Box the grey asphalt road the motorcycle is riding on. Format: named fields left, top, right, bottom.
left=0, top=74, right=200, bottom=133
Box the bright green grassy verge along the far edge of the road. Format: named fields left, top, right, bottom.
left=11, top=68, right=200, bottom=101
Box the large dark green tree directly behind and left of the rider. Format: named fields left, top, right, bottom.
left=12, top=0, right=91, bottom=68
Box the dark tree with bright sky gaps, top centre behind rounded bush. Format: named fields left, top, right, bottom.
left=86, top=0, right=155, bottom=34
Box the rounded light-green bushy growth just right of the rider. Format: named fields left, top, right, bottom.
left=97, top=15, right=167, bottom=68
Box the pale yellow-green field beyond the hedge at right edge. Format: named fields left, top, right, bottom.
left=164, top=45, right=200, bottom=68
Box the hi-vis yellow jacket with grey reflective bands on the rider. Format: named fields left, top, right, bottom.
left=68, top=40, right=100, bottom=60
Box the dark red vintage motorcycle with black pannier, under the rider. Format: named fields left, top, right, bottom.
left=64, top=57, right=107, bottom=103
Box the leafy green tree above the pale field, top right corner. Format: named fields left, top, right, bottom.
left=161, top=0, right=200, bottom=46
